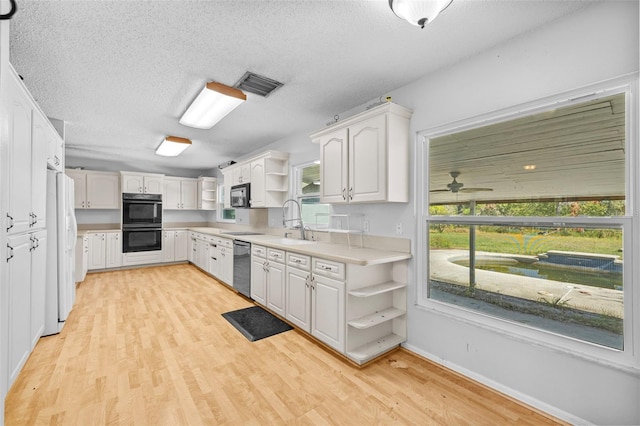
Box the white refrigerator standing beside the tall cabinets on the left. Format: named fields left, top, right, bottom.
left=43, top=170, right=78, bottom=336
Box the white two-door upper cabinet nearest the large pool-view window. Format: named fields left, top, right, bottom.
left=311, top=102, right=411, bottom=204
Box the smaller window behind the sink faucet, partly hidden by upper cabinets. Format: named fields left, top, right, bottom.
left=294, top=161, right=329, bottom=227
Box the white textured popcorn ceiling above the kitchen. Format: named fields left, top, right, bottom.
left=11, top=0, right=592, bottom=170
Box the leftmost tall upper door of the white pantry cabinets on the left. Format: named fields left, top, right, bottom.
left=2, top=73, right=32, bottom=234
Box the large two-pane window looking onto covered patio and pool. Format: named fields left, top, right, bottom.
left=421, top=88, right=638, bottom=360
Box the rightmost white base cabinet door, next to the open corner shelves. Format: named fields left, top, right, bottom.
left=311, top=275, right=345, bottom=352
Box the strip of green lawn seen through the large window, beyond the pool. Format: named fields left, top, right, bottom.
left=429, top=228, right=622, bottom=258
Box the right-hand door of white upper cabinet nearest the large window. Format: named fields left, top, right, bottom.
left=347, top=115, right=387, bottom=202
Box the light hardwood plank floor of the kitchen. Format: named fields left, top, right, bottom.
left=5, top=265, right=557, bottom=425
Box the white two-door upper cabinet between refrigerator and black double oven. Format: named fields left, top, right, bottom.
left=65, top=169, right=121, bottom=209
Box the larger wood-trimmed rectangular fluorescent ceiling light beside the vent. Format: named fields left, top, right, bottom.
left=180, top=82, right=247, bottom=129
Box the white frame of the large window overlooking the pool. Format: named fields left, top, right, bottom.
left=414, top=73, right=640, bottom=374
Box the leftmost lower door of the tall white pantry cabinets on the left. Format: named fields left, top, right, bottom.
left=3, top=234, right=31, bottom=387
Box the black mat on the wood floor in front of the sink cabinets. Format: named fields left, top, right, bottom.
left=222, top=306, right=293, bottom=342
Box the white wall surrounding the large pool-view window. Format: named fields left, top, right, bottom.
left=240, top=1, right=640, bottom=424
